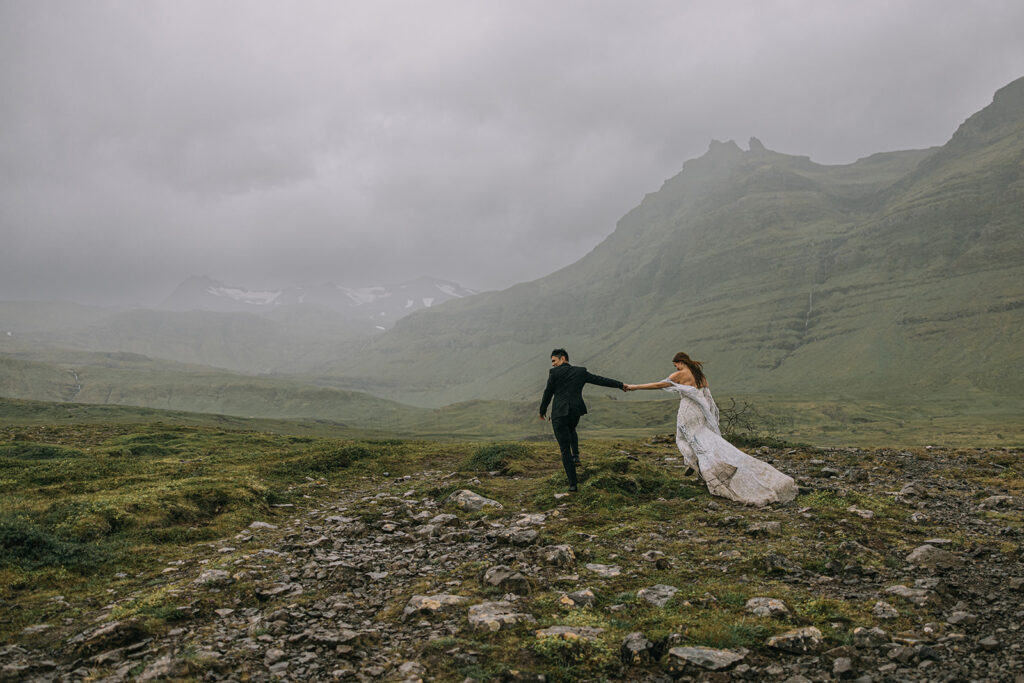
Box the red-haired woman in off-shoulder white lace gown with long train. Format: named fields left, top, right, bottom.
left=625, top=351, right=797, bottom=505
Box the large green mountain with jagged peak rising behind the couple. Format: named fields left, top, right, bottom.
left=318, top=79, right=1024, bottom=405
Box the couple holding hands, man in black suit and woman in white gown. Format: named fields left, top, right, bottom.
left=540, top=348, right=797, bottom=505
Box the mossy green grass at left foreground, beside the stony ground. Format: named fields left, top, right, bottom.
left=0, top=424, right=404, bottom=634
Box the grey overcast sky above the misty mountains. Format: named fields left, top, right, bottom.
left=0, top=0, right=1024, bottom=303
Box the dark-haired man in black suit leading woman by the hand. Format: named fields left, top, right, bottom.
left=541, top=348, right=626, bottom=490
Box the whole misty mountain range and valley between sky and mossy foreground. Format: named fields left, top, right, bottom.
left=0, top=80, right=1024, bottom=446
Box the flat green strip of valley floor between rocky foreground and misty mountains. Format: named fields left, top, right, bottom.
left=8, top=382, right=1024, bottom=446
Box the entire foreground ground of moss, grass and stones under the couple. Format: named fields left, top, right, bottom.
left=0, top=423, right=1024, bottom=681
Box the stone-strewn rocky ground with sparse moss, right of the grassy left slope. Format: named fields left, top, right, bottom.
left=0, top=442, right=1024, bottom=683
